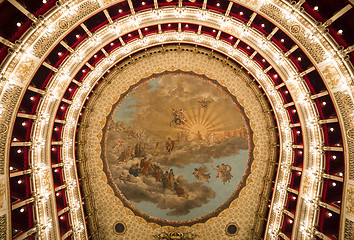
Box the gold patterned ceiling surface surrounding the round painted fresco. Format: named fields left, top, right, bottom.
left=75, top=45, right=275, bottom=239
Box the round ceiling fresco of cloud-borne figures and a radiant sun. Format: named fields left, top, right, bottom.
left=104, top=74, right=249, bottom=221
